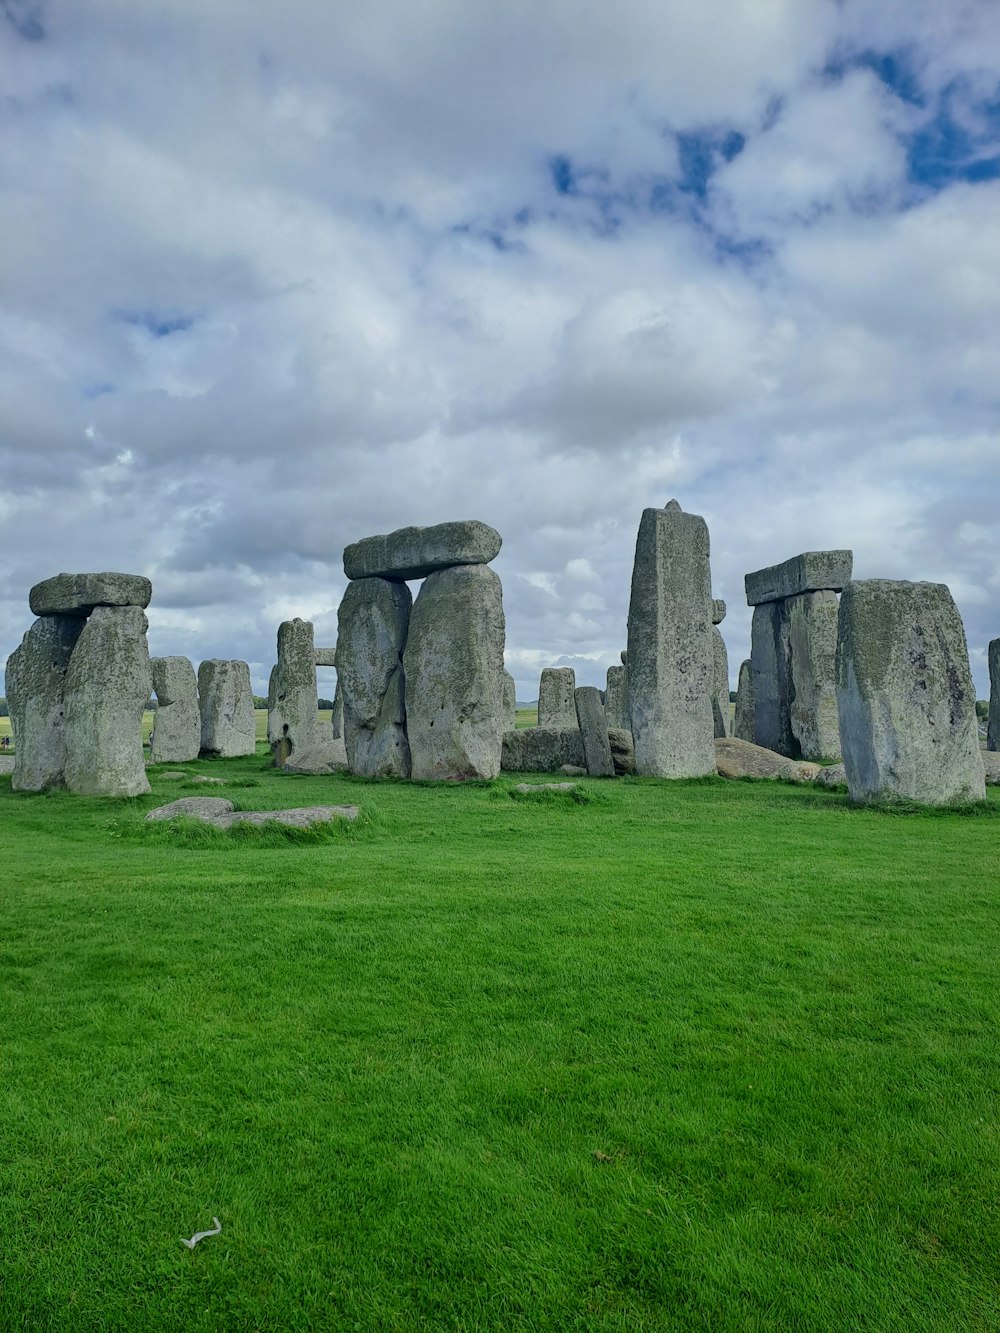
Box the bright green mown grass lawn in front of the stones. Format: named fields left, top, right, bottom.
left=0, top=748, right=1000, bottom=1333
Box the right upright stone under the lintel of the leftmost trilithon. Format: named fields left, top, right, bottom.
left=64, top=607, right=153, bottom=796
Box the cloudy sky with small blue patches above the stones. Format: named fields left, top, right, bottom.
left=0, top=0, right=1000, bottom=698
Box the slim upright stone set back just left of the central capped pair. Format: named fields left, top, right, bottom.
left=268, top=617, right=344, bottom=773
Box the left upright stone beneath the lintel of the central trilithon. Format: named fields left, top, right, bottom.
left=337, top=579, right=413, bottom=777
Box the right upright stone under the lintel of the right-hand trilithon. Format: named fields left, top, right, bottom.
left=789, top=592, right=840, bottom=760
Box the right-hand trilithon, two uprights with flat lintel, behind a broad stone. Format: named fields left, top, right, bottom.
left=744, top=551, right=853, bottom=760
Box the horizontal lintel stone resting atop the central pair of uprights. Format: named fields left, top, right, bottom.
left=344, top=519, right=501, bottom=579
